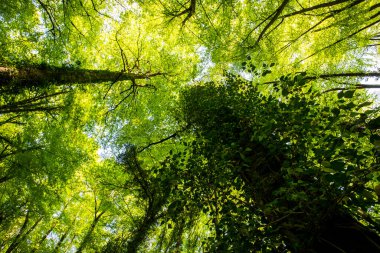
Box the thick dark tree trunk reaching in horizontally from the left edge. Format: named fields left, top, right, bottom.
left=0, top=66, right=162, bottom=88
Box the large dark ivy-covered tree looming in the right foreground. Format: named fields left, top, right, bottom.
left=168, top=74, right=380, bottom=252
